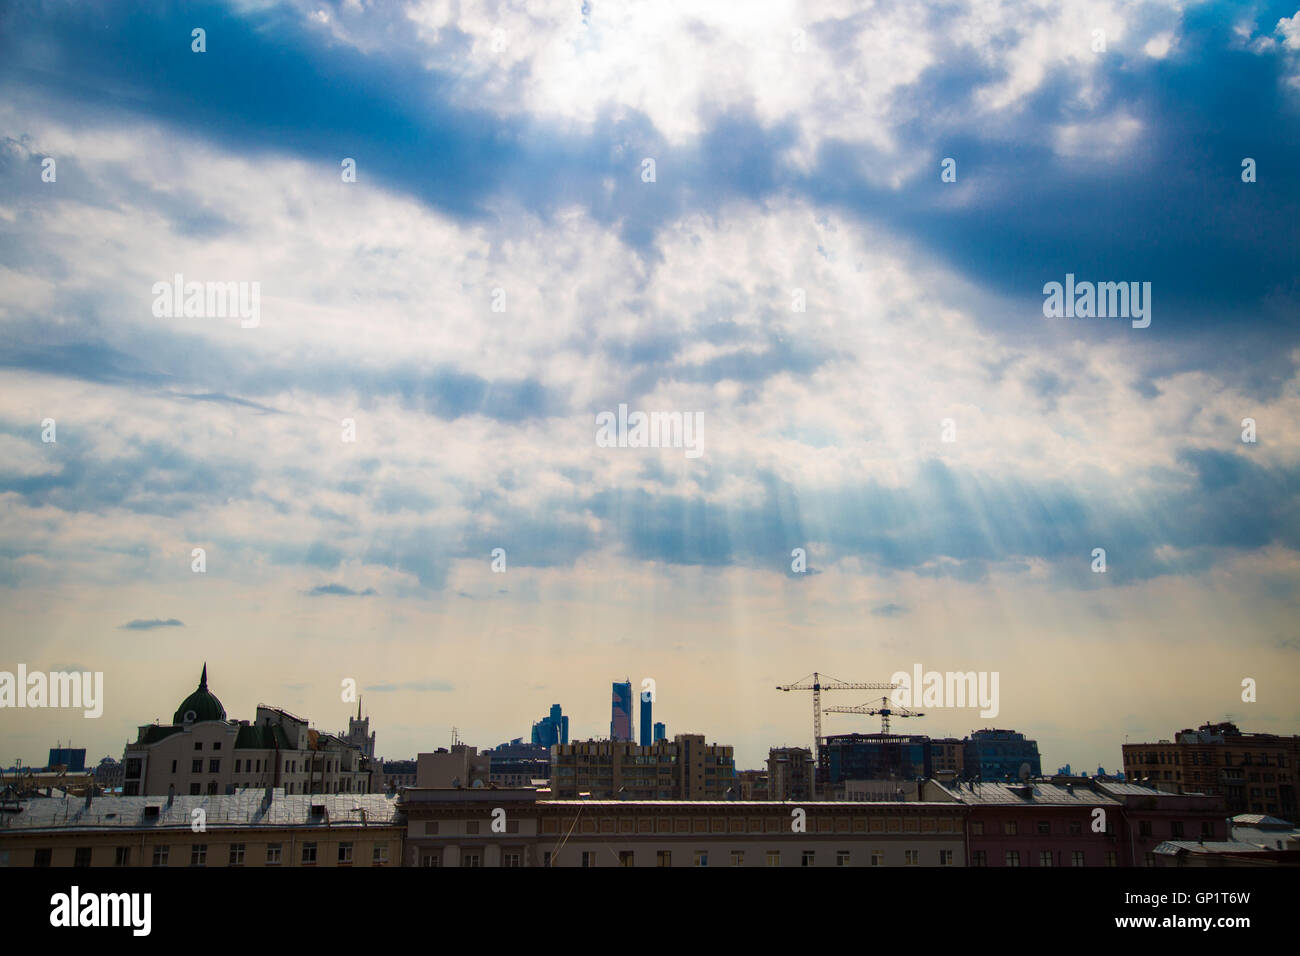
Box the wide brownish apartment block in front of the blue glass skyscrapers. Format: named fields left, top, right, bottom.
left=550, top=734, right=736, bottom=800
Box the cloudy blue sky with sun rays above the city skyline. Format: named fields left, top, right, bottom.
left=0, top=0, right=1300, bottom=771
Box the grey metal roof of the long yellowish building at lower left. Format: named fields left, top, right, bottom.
left=0, top=788, right=400, bottom=832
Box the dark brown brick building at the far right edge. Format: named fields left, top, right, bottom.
left=1123, top=723, right=1300, bottom=819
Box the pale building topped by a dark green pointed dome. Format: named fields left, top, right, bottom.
left=122, top=665, right=378, bottom=796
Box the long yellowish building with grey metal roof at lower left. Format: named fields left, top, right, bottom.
left=0, top=788, right=406, bottom=866
